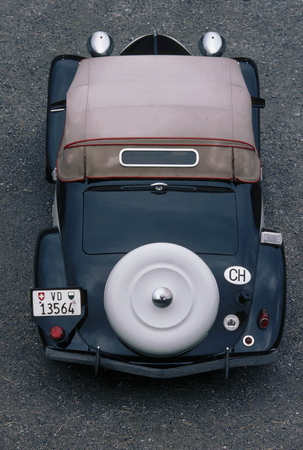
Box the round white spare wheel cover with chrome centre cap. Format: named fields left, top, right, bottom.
left=104, top=243, right=219, bottom=357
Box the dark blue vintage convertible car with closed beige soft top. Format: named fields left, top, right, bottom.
left=31, top=32, right=286, bottom=378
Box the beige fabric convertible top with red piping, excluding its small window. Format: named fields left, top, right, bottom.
left=58, top=55, right=260, bottom=182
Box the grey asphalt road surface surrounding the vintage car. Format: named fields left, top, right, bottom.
left=0, top=0, right=303, bottom=450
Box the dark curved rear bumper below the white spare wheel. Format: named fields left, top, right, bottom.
left=45, top=347, right=278, bottom=378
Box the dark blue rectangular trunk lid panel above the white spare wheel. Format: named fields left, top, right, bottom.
left=83, top=185, right=238, bottom=255
